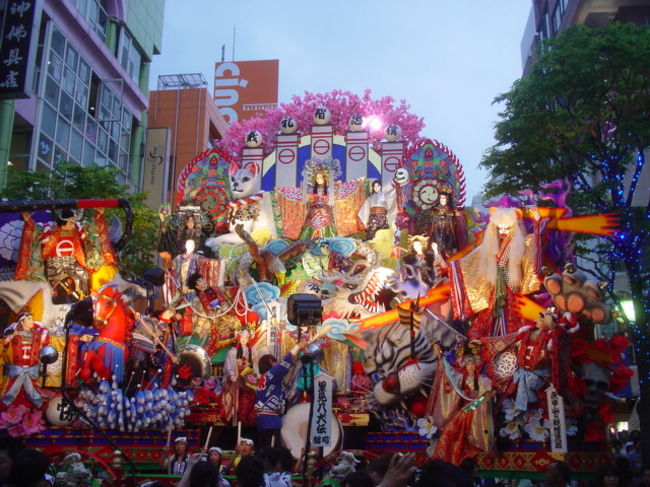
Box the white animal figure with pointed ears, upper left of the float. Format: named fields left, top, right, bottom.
left=205, top=162, right=277, bottom=253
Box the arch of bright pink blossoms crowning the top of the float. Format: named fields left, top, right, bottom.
left=217, top=90, right=424, bottom=157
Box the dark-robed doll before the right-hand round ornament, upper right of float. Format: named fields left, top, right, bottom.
left=429, top=185, right=467, bottom=259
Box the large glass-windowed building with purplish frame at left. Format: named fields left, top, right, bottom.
left=0, top=0, right=165, bottom=188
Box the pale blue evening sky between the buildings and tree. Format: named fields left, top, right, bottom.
left=150, top=0, right=531, bottom=202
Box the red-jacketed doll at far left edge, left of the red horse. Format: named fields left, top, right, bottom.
left=2, top=313, right=50, bottom=408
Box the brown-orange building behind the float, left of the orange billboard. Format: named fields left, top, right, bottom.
left=149, top=73, right=228, bottom=203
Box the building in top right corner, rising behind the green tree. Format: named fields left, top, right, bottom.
left=521, top=0, right=650, bottom=75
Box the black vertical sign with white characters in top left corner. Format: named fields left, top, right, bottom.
left=0, top=0, right=40, bottom=98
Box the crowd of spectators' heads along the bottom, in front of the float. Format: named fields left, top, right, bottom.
left=0, top=428, right=650, bottom=487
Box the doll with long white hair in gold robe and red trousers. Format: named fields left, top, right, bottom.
left=449, top=208, right=542, bottom=338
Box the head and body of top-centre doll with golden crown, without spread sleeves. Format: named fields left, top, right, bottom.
left=300, top=160, right=341, bottom=240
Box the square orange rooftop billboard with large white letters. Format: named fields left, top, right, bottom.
left=214, top=59, right=279, bottom=124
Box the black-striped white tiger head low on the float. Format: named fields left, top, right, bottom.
left=364, top=313, right=464, bottom=407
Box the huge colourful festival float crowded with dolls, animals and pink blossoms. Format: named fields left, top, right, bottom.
left=0, top=93, right=631, bottom=484
